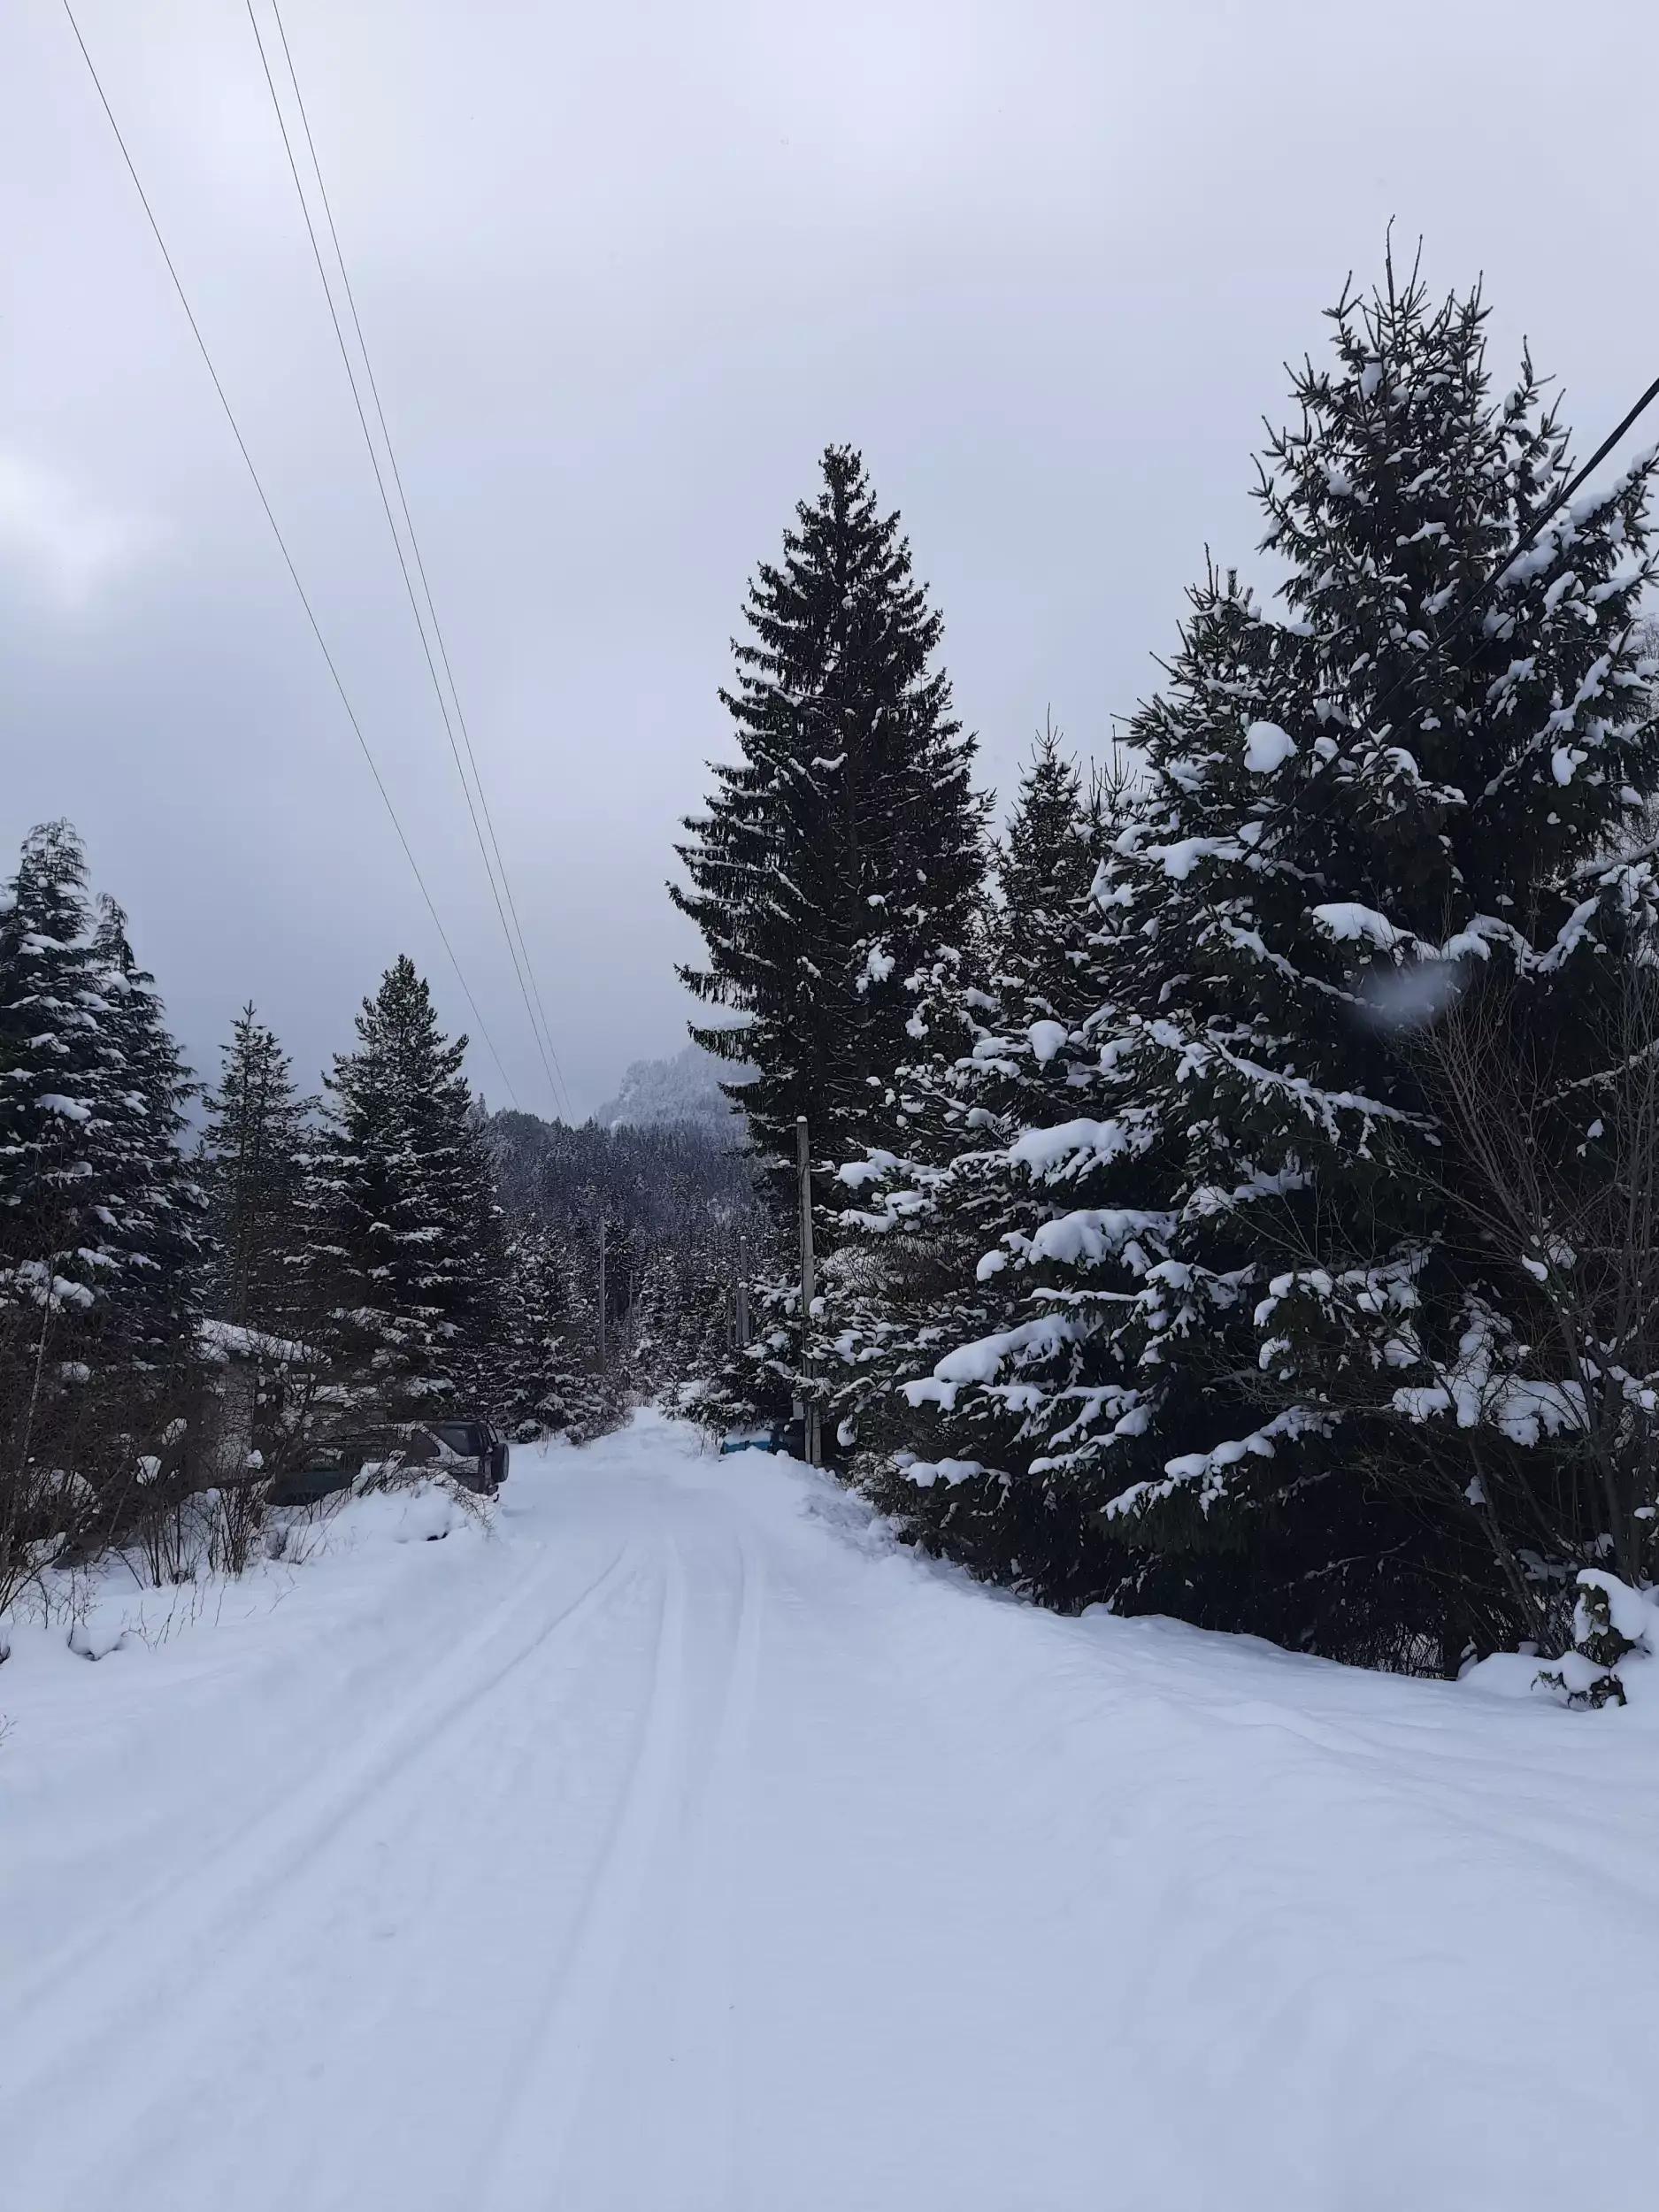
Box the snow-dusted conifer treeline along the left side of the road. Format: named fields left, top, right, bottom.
left=0, top=821, right=746, bottom=1606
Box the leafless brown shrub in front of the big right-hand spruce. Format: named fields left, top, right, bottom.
left=1416, top=947, right=1659, bottom=1613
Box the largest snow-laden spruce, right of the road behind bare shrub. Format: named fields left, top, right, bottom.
left=902, top=281, right=1657, bottom=1666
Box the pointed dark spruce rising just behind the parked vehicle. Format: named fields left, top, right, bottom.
left=308, top=956, right=498, bottom=1425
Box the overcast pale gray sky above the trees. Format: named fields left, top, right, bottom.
left=0, top=0, right=1659, bottom=1110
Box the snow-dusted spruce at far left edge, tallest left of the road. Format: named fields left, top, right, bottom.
left=0, top=823, right=202, bottom=1582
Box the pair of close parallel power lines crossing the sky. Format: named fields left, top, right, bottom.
left=246, top=0, right=571, bottom=1113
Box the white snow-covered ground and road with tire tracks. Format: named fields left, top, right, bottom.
left=0, top=1420, right=1659, bottom=2212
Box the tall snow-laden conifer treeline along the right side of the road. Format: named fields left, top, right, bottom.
left=675, top=270, right=1659, bottom=1671
